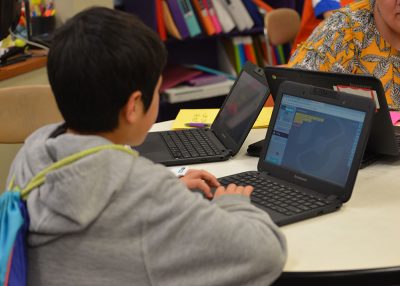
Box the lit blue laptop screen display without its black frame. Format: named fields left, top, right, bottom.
left=265, top=94, right=366, bottom=186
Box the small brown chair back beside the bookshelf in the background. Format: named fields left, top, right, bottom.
left=264, top=8, right=300, bottom=46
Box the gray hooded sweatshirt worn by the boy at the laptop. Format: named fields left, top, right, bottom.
left=9, top=125, right=286, bottom=286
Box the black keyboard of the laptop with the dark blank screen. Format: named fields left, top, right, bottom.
left=161, top=129, right=221, bottom=159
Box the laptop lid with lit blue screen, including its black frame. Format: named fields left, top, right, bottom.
left=258, top=81, right=375, bottom=202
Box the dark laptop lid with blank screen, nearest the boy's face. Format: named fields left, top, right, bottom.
left=211, top=62, right=270, bottom=155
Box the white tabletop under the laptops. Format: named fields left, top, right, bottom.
left=152, top=121, right=400, bottom=271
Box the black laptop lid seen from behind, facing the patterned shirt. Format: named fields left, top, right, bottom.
left=264, top=66, right=399, bottom=156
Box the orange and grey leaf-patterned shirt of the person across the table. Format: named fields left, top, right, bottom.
left=288, top=0, right=400, bottom=110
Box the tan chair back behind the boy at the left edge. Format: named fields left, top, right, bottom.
left=0, top=85, right=62, bottom=192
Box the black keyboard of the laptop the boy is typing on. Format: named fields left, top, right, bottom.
left=219, top=172, right=329, bottom=215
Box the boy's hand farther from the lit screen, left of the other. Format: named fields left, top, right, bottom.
left=180, top=169, right=221, bottom=199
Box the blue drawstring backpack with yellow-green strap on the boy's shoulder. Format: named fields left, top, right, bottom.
left=0, top=144, right=137, bottom=286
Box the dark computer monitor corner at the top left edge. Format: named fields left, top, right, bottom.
left=0, top=0, right=21, bottom=40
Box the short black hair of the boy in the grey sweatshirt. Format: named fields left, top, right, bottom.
left=47, top=7, right=167, bottom=132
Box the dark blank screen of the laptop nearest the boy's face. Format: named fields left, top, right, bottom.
left=216, top=71, right=269, bottom=144
